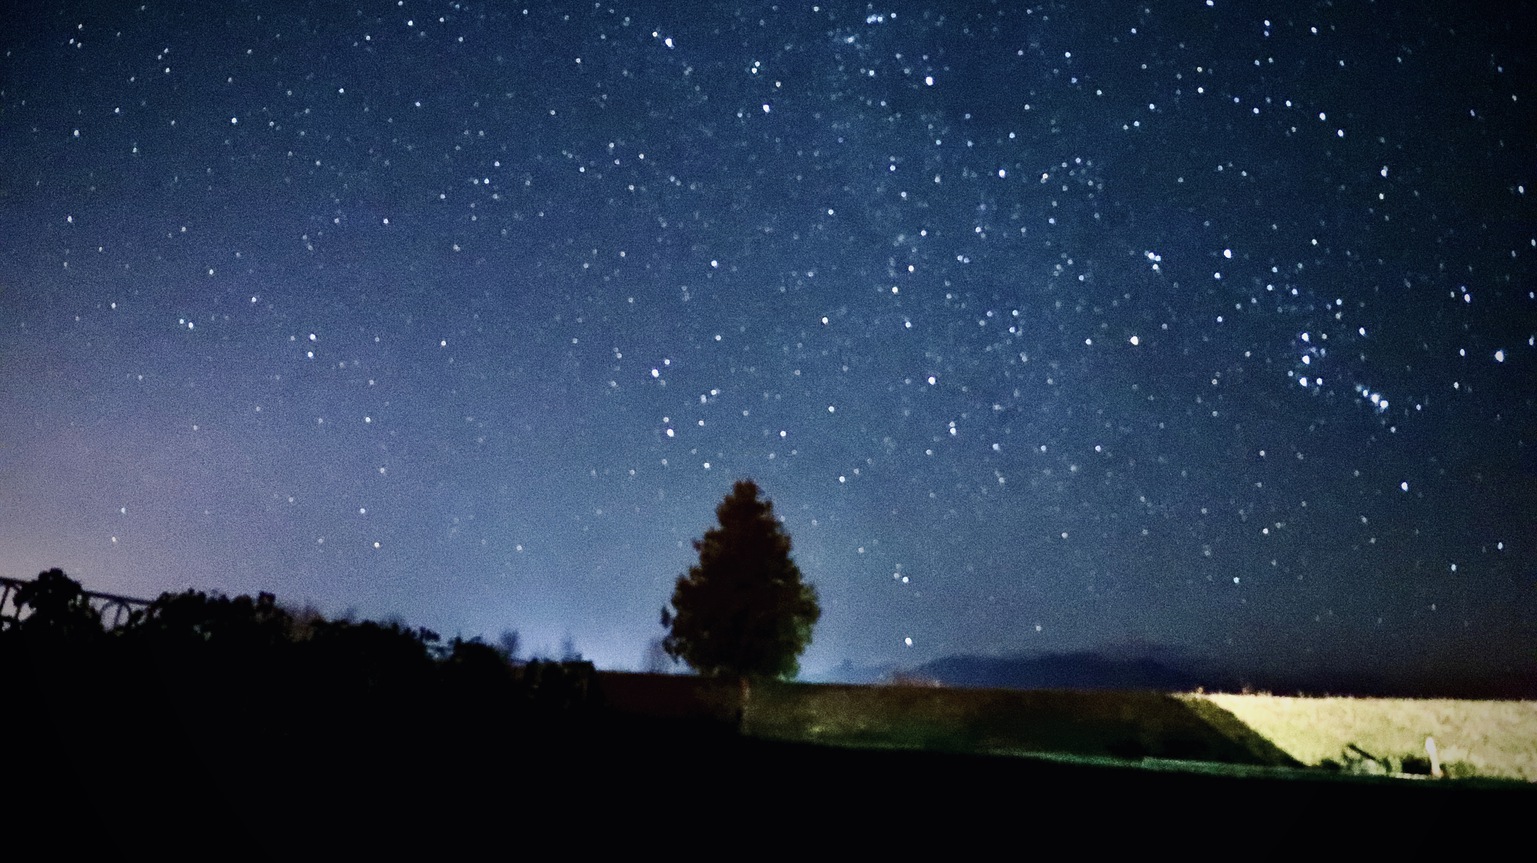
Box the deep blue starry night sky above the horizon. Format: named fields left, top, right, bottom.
left=0, top=0, right=1537, bottom=683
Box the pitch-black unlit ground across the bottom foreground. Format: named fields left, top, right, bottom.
left=9, top=658, right=1537, bottom=860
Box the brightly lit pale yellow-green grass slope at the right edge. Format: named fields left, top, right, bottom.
left=1180, top=694, right=1537, bottom=781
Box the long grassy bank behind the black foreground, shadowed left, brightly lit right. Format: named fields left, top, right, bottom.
left=603, top=674, right=1537, bottom=781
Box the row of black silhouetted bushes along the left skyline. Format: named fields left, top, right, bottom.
left=0, top=569, right=593, bottom=728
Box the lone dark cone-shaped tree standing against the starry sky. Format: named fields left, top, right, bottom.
left=662, top=480, right=822, bottom=679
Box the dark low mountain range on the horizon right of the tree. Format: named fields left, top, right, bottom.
left=808, top=651, right=1537, bottom=698
